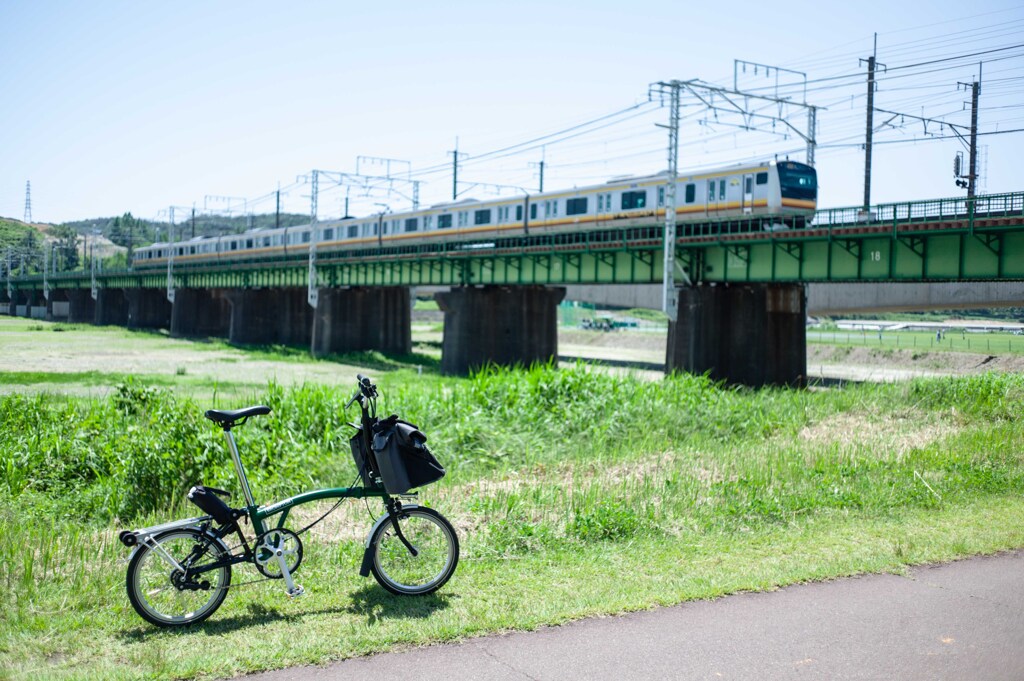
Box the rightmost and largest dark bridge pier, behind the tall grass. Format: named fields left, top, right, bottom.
left=665, top=284, right=807, bottom=387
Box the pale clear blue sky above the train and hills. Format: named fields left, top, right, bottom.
left=0, top=0, right=1024, bottom=222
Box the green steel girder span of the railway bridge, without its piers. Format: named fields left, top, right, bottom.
left=9, top=193, right=1024, bottom=292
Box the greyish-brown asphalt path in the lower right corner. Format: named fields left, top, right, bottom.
left=247, top=552, right=1024, bottom=681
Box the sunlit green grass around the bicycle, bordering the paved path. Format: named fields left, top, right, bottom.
left=0, top=319, right=1024, bottom=679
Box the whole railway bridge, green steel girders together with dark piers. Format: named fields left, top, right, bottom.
left=0, top=193, right=1024, bottom=386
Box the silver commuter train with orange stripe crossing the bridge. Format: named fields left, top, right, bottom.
left=132, top=161, right=817, bottom=268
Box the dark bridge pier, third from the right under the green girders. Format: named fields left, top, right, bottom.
left=310, top=286, right=413, bottom=356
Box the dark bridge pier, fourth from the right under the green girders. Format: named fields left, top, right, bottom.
left=226, top=287, right=313, bottom=345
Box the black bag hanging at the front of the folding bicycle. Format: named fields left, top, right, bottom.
left=373, top=416, right=444, bottom=495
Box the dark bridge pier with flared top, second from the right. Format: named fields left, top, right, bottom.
left=434, top=286, right=565, bottom=374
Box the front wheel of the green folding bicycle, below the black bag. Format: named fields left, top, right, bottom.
left=371, top=508, right=459, bottom=596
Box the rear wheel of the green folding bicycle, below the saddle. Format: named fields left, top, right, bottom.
left=125, top=528, right=231, bottom=627
